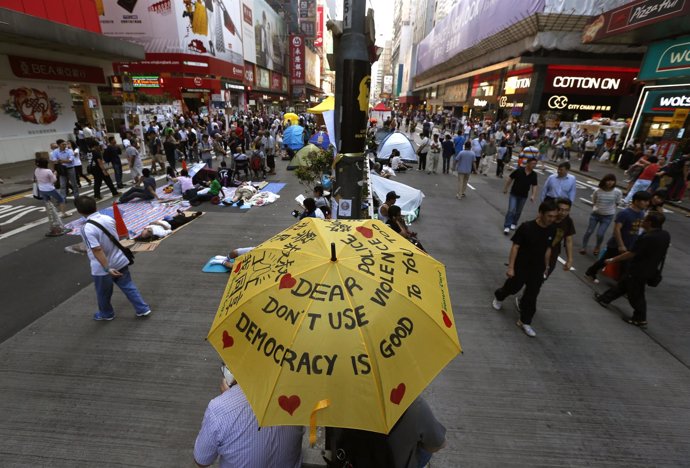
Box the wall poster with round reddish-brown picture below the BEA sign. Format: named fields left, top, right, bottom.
left=0, top=81, right=77, bottom=138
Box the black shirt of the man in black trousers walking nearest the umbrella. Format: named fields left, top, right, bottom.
left=511, top=221, right=556, bottom=273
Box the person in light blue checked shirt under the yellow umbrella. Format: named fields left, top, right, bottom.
left=194, top=366, right=304, bottom=468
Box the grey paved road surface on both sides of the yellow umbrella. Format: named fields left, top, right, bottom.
left=0, top=151, right=690, bottom=467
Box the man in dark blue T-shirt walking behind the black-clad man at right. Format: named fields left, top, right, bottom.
left=585, top=192, right=652, bottom=283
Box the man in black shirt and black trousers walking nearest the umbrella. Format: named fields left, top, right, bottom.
left=491, top=199, right=558, bottom=338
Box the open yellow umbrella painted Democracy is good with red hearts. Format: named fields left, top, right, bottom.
left=208, top=218, right=460, bottom=440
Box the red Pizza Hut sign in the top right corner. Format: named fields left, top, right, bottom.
left=582, top=0, right=690, bottom=44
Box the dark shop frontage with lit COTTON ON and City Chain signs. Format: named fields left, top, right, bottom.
left=539, top=65, right=638, bottom=126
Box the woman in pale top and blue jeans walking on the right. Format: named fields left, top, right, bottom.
left=580, top=174, right=623, bottom=257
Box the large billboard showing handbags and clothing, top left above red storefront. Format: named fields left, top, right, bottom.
left=100, top=0, right=244, bottom=65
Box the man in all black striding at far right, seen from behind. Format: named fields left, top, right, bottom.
left=594, top=211, right=671, bottom=328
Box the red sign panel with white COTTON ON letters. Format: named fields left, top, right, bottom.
left=544, top=65, right=638, bottom=96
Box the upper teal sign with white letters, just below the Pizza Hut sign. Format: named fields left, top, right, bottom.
left=638, top=36, right=690, bottom=80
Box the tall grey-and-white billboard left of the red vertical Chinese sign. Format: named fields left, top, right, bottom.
left=247, top=0, right=287, bottom=73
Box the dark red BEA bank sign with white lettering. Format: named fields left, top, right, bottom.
left=8, top=55, right=105, bottom=84
